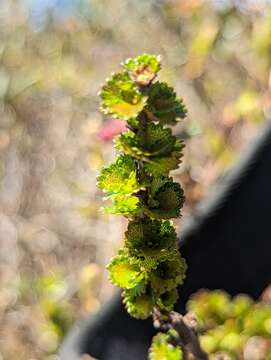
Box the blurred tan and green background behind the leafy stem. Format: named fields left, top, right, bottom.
left=0, top=0, right=271, bottom=360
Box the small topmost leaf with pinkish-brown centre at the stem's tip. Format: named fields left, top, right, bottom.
left=123, top=54, right=161, bottom=86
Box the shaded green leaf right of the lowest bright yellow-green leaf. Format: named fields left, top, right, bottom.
left=150, top=253, right=186, bottom=294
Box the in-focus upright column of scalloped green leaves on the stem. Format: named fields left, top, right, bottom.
left=97, top=54, right=186, bottom=320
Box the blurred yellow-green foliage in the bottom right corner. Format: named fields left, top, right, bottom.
left=187, top=290, right=271, bottom=360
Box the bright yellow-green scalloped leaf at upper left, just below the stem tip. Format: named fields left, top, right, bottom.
left=100, top=72, right=146, bottom=120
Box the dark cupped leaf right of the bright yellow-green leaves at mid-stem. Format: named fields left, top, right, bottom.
left=143, top=176, right=184, bottom=219
